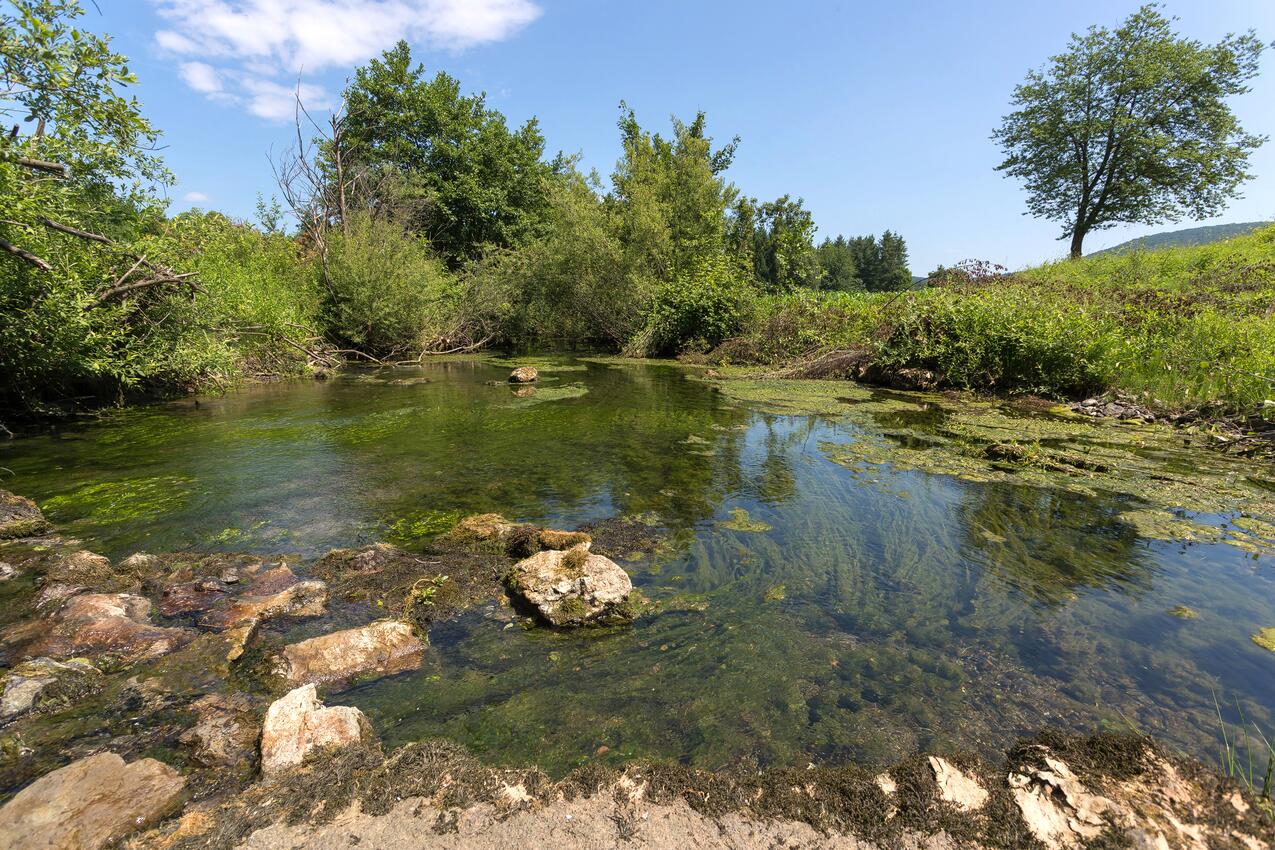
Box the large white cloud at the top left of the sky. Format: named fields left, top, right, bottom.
left=153, top=0, right=541, bottom=119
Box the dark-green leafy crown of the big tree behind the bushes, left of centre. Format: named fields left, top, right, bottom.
left=343, top=41, right=553, bottom=266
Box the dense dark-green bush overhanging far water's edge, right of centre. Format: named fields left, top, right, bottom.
left=631, top=255, right=752, bottom=356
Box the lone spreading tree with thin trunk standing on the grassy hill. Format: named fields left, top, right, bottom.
left=992, top=4, right=1265, bottom=257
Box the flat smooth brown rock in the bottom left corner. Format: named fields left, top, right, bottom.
left=0, top=753, right=186, bottom=850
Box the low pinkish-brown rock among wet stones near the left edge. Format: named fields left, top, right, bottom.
left=5, top=594, right=194, bottom=663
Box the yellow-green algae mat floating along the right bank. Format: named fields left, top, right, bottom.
left=713, top=371, right=1275, bottom=554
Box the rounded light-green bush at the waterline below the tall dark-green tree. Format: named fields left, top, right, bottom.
left=321, top=213, right=462, bottom=358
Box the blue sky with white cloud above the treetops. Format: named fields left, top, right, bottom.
left=92, top=0, right=1275, bottom=274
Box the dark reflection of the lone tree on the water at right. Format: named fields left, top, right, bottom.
left=956, top=484, right=1153, bottom=605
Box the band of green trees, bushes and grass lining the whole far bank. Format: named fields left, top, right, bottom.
left=0, top=3, right=1275, bottom=449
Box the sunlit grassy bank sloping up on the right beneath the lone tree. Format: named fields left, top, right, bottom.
left=710, top=227, right=1275, bottom=418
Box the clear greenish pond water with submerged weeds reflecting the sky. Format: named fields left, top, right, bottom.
left=0, top=361, right=1275, bottom=772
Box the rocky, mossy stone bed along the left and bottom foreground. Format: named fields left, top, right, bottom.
left=0, top=492, right=1275, bottom=850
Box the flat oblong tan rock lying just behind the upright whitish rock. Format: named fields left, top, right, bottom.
left=275, top=619, right=425, bottom=687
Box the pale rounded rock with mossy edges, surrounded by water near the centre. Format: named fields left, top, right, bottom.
left=506, top=545, right=634, bottom=626
